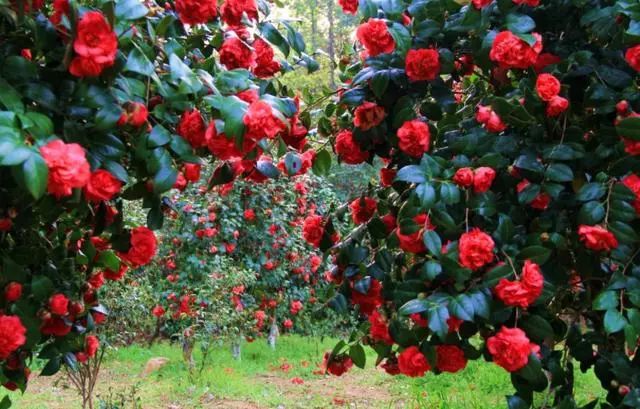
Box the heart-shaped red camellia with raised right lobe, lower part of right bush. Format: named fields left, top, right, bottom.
left=494, top=260, right=544, bottom=308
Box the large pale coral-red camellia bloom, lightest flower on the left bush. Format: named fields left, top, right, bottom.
left=40, top=139, right=91, bottom=198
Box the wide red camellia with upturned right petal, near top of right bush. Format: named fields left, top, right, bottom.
left=489, top=31, right=542, bottom=69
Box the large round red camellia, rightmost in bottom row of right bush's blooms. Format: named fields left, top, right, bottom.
left=487, top=327, right=539, bottom=372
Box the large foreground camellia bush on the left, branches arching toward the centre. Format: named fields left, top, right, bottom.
left=0, top=0, right=322, bottom=408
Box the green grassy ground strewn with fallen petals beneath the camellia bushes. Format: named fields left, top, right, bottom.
left=7, top=336, right=600, bottom=409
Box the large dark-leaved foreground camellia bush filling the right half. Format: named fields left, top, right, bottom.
left=314, top=0, right=640, bottom=408
